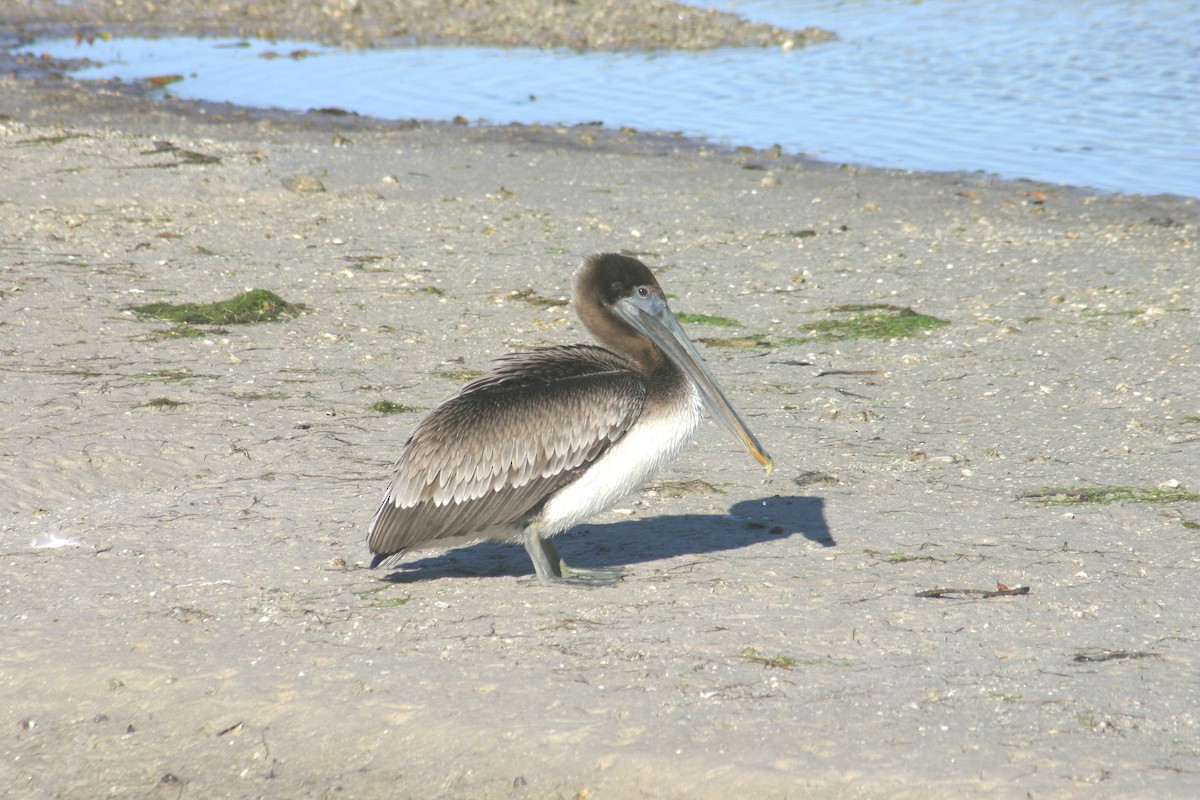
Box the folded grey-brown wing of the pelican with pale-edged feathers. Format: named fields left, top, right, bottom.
left=367, top=345, right=646, bottom=563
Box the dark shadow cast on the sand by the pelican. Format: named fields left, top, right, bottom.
left=383, top=495, right=838, bottom=583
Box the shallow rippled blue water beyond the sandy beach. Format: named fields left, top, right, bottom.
left=21, top=0, right=1200, bottom=197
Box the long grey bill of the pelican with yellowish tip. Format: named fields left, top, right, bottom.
left=612, top=294, right=775, bottom=473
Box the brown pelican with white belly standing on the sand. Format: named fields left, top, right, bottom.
left=367, top=253, right=774, bottom=583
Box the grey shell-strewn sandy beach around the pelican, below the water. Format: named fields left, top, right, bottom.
left=0, top=4, right=1200, bottom=800
